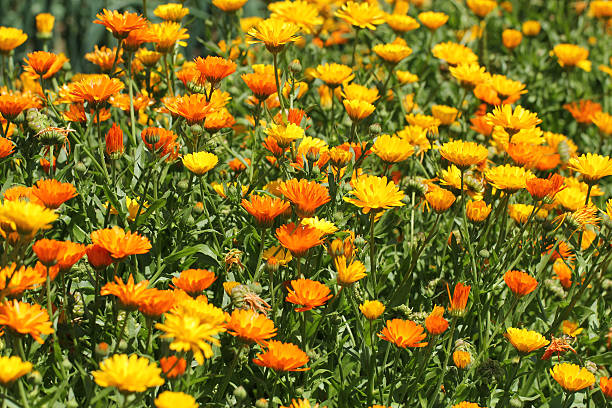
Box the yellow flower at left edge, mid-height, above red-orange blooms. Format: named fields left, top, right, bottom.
left=0, top=200, right=58, bottom=236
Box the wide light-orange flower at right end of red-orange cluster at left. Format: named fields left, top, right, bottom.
left=91, top=226, right=151, bottom=261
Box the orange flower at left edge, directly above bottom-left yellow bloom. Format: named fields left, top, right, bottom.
left=0, top=300, right=53, bottom=344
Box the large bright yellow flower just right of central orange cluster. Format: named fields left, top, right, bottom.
left=344, top=174, right=404, bottom=214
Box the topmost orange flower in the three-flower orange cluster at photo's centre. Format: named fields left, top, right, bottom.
left=279, top=179, right=331, bottom=218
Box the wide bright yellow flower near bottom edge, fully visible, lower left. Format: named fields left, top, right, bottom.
left=91, top=354, right=164, bottom=394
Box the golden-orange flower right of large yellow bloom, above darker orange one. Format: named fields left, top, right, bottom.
left=227, top=309, right=276, bottom=344
